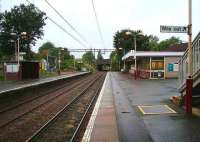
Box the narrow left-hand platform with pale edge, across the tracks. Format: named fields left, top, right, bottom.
left=0, top=72, right=87, bottom=94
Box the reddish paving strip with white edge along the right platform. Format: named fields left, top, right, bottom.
left=82, top=73, right=119, bottom=142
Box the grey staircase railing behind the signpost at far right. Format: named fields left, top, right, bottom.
left=179, top=33, right=200, bottom=88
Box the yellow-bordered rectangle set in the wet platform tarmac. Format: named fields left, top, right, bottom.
left=138, top=105, right=176, bottom=114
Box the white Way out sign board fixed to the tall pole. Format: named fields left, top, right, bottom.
left=160, top=25, right=187, bottom=33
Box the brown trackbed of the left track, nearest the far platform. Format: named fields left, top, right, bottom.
left=0, top=73, right=96, bottom=128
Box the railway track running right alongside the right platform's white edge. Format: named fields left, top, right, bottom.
left=26, top=74, right=105, bottom=142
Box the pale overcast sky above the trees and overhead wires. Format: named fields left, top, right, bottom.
left=0, top=0, right=200, bottom=57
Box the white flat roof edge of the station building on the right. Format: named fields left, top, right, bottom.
left=122, top=50, right=184, bottom=60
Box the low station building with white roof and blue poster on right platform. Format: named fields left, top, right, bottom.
left=122, top=43, right=187, bottom=79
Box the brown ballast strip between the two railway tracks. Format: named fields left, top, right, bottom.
left=0, top=74, right=102, bottom=142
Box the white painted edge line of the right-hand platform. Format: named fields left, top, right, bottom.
left=82, top=73, right=109, bottom=142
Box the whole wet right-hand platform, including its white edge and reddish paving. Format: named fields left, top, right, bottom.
left=82, top=72, right=200, bottom=142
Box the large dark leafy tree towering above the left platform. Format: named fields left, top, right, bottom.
left=0, top=4, right=46, bottom=59
